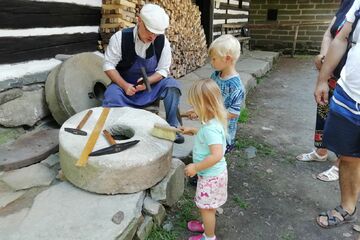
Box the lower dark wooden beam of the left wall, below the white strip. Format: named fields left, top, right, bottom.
left=0, top=33, right=99, bottom=64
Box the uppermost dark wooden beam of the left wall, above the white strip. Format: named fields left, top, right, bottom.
left=0, top=0, right=101, bottom=29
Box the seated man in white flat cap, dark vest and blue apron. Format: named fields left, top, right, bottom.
left=103, top=4, right=184, bottom=143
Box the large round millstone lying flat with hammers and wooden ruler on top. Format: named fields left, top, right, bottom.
left=59, top=107, right=173, bottom=194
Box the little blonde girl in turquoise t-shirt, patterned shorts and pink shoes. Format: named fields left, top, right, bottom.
left=182, top=79, right=228, bottom=240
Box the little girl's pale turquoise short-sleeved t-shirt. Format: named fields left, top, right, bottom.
left=193, top=119, right=226, bottom=177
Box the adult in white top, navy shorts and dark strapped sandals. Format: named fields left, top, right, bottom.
left=314, top=0, right=360, bottom=228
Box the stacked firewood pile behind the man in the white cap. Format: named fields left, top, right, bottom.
left=100, top=0, right=207, bottom=78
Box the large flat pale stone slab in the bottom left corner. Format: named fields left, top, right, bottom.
left=0, top=182, right=145, bottom=240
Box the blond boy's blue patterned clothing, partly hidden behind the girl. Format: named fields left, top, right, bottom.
left=210, top=71, right=245, bottom=145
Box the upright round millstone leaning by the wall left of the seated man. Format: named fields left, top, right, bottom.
left=45, top=53, right=111, bottom=124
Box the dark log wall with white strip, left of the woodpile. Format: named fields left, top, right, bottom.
left=0, top=0, right=101, bottom=65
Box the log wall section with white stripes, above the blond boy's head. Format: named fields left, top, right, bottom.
left=213, top=0, right=250, bottom=38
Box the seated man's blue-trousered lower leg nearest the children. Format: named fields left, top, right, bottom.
left=161, top=87, right=181, bottom=127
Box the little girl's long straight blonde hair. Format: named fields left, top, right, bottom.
left=188, top=79, right=227, bottom=131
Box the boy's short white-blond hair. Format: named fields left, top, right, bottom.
left=209, top=34, right=241, bottom=62
